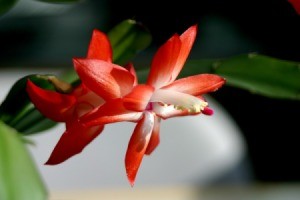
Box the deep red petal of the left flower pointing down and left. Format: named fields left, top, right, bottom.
left=45, top=120, right=104, bottom=165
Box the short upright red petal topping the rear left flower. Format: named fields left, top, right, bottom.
left=87, top=29, right=112, bottom=62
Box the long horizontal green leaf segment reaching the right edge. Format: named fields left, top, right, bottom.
left=183, top=54, right=300, bottom=100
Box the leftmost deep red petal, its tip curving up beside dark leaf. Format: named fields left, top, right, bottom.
left=26, top=80, right=76, bottom=122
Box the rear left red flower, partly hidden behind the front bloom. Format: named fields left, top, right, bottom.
left=27, top=30, right=135, bottom=165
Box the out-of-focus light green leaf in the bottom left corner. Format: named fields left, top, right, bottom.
left=0, top=121, right=48, bottom=200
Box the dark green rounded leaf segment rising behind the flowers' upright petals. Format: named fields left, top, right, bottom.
left=108, top=20, right=152, bottom=65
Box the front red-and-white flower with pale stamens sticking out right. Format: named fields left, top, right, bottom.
left=75, top=25, right=225, bottom=186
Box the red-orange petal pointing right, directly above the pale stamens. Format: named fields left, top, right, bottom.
left=162, top=74, right=225, bottom=96
